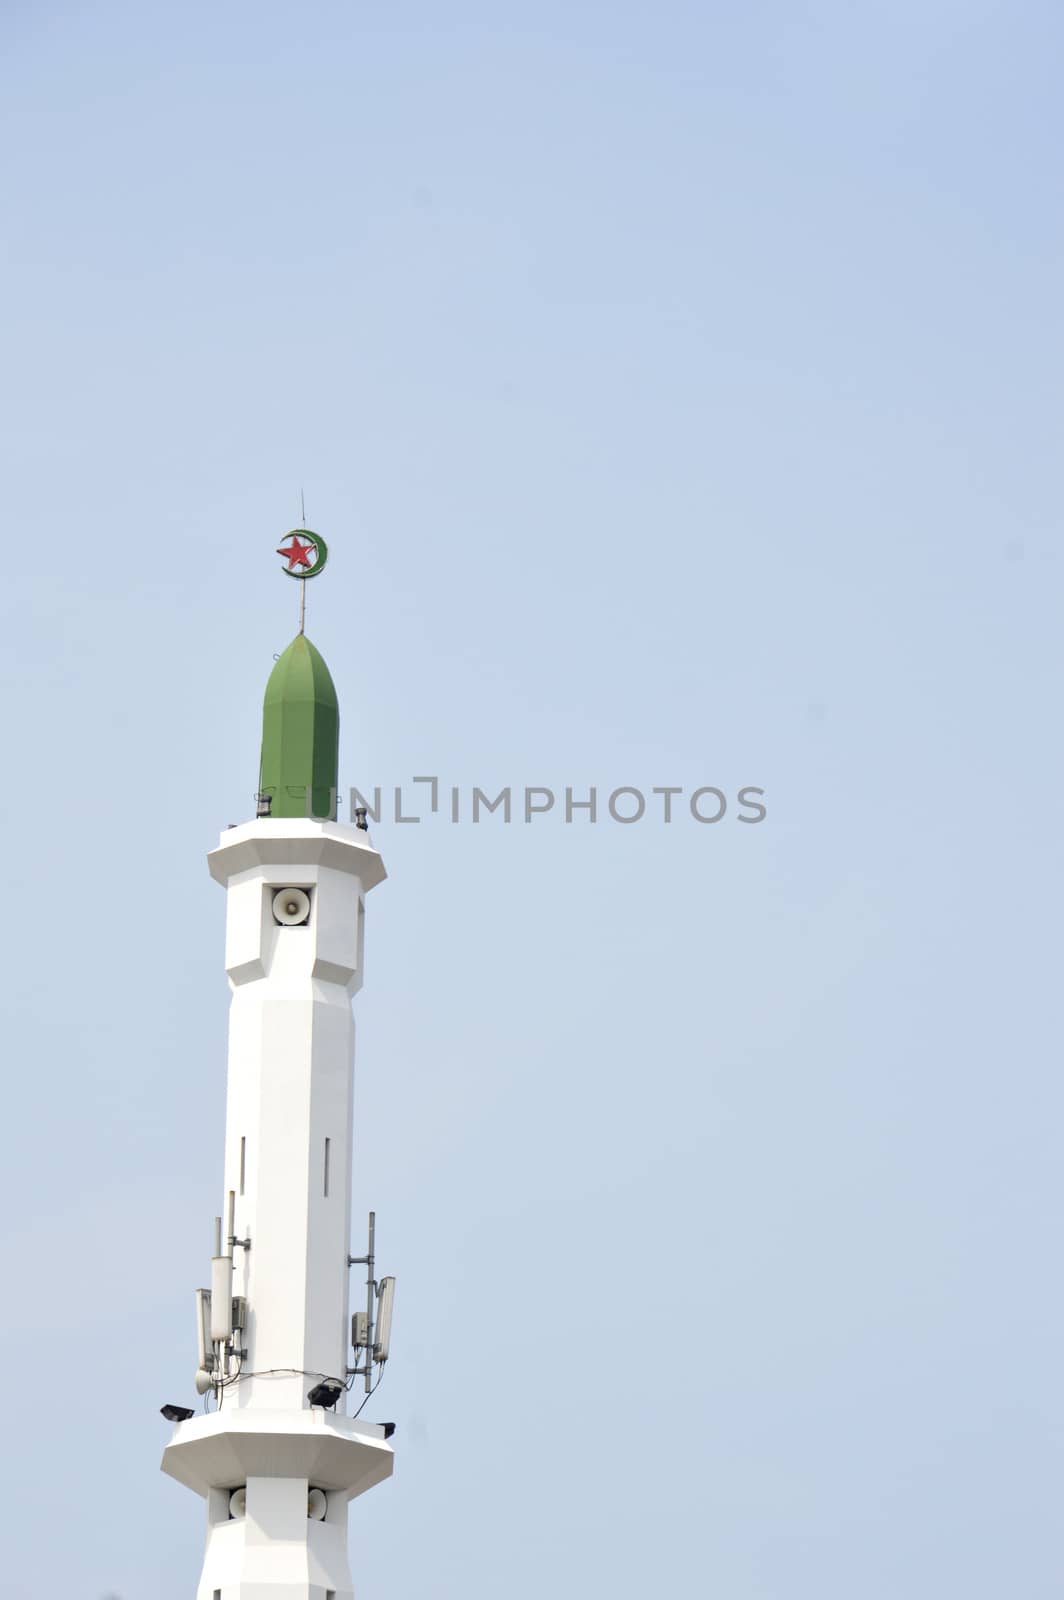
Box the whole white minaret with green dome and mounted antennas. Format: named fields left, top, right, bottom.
left=156, top=534, right=392, bottom=1600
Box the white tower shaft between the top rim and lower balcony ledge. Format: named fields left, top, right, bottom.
left=226, top=861, right=362, bottom=1406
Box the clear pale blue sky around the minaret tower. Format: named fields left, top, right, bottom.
left=0, top=0, right=1064, bottom=1600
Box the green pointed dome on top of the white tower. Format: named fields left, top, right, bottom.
left=259, top=634, right=339, bottom=818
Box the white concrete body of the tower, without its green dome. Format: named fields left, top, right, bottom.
left=163, top=818, right=392, bottom=1600
